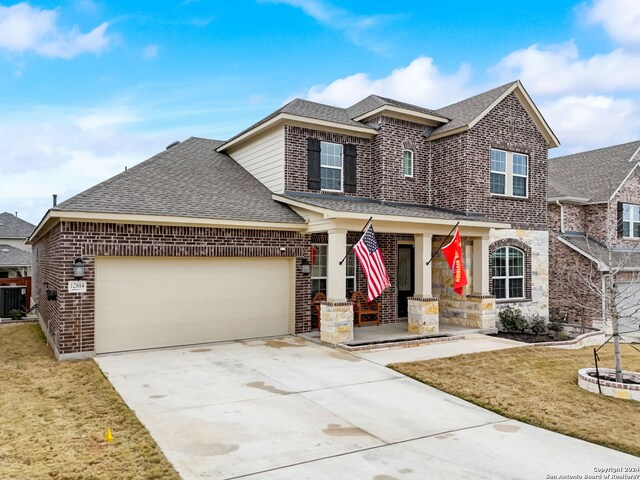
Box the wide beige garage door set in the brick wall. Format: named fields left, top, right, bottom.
left=95, top=257, right=294, bottom=353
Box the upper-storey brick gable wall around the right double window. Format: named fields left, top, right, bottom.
left=432, top=93, right=548, bottom=230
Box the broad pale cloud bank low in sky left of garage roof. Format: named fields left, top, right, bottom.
left=0, top=109, right=180, bottom=223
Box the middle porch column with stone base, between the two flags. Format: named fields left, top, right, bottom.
left=408, top=234, right=439, bottom=335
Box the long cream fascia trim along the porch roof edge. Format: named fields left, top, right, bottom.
left=272, top=193, right=511, bottom=229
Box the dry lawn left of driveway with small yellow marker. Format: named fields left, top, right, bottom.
left=0, top=324, right=179, bottom=480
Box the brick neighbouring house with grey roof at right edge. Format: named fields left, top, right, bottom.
left=548, top=141, right=640, bottom=331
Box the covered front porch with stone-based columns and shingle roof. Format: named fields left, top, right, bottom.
left=274, top=195, right=509, bottom=344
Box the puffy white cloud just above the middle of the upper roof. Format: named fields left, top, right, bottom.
left=305, top=57, right=475, bottom=108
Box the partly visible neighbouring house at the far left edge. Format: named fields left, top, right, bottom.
left=0, top=212, right=36, bottom=278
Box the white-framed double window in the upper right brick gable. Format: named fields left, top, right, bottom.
left=491, top=148, right=529, bottom=198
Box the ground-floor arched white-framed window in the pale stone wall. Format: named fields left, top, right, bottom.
left=491, top=247, right=525, bottom=299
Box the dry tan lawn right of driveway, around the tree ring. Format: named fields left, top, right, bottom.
left=390, top=345, right=640, bottom=456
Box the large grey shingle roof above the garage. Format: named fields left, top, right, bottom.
left=52, top=137, right=304, bottom=223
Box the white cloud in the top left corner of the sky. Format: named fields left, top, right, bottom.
left=0, top=3, right=109, bottom=59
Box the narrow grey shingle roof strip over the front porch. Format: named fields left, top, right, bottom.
left=281, top=192, right=485, bottom=221
